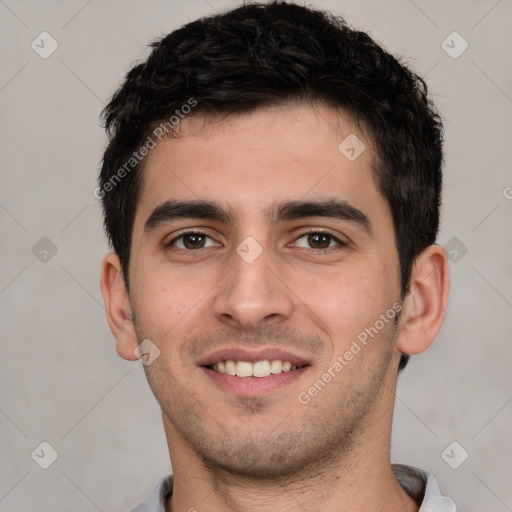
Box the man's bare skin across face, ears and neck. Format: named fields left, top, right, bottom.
left=101, top=104, right=449, bottom=512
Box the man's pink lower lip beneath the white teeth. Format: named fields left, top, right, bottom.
left=201, top=366, right=309, bottom=397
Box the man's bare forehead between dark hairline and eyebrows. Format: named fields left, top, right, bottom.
left=132, top=104, right=387, bottom=224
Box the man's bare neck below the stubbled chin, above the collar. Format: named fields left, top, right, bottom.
left=167, top=444, right=418, bottom=512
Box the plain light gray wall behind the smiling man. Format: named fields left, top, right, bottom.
left=0, top=0, right=512, bottom=512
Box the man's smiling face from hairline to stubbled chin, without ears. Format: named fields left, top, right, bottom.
left=129, top=105, right=400, bottom=477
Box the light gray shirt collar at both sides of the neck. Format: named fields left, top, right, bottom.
left=130, top=464, right=456, bottom=512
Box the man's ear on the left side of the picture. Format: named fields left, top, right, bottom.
left=100, top=253, right=138, bottom=361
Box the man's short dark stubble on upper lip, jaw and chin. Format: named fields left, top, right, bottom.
left=138, top=322, right=397, bottom=481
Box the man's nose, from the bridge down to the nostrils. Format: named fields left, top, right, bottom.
left=213, top=241, right=295, bottom=329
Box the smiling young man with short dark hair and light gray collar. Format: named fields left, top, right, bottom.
left=96, top=2, right=455, bottom=512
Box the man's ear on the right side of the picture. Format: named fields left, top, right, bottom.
left=397, top=245, right=450, bottom=355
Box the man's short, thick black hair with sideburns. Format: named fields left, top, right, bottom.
left=96, top=1, right=443, bottom=368
